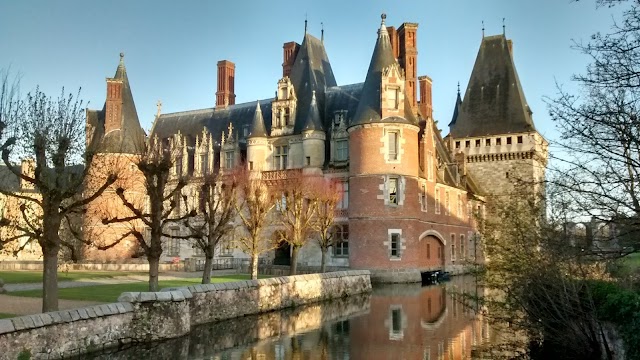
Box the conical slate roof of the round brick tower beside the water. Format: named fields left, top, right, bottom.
left=351, top=14, right=417, bottom=126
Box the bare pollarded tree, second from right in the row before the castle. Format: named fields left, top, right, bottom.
left=276, top=174, right=321, bottom=275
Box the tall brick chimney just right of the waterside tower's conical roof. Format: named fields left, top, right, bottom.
left=398, top=23, right=418, bottom=114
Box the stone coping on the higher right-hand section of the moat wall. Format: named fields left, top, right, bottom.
left=118, top=270, right=371, bottom=303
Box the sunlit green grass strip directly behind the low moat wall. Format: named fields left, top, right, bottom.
left=11, top=275, right=262, bottom=303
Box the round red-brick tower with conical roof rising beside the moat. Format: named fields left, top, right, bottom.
left=348, top=14, right=420, bottom=281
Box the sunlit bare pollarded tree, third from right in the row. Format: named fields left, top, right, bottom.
left=234, top=170, right=276, bottom=280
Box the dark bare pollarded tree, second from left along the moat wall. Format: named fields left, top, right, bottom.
left=102, top=138, right=196, bottom=291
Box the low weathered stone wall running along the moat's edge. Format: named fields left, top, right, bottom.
left=0, top=270, right=371, bottom=359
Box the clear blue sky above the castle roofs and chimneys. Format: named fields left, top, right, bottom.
left=0, top=0, right=621, bottom=143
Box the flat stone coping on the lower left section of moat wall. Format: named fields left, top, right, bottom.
left=0, top=302, right=133, bottom=335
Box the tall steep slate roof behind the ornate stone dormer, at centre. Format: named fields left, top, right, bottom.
left=289, top=33, right=337, bottom=134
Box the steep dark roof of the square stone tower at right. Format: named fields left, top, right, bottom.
left=449, top=35, right=535, bottom=138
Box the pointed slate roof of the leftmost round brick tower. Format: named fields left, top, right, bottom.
left=87, top=54, right=146, bottom=154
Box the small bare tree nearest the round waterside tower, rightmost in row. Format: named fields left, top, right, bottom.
left=313, top=180, right=341, bottom=272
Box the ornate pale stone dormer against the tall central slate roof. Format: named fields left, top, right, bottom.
left=271, top=76, right=298, bottom=136
